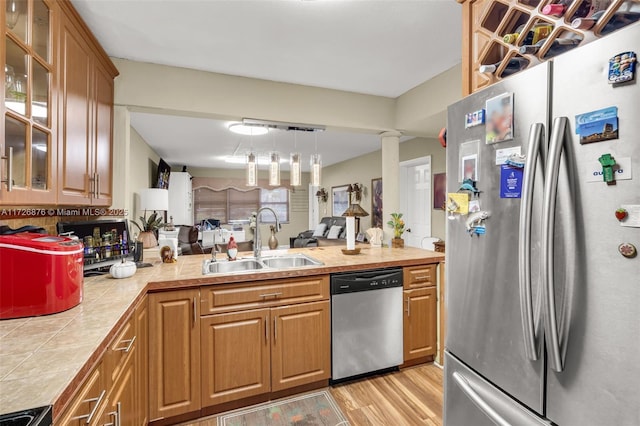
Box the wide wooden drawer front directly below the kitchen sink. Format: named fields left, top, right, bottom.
left=200, top=275, right=329, bottom=315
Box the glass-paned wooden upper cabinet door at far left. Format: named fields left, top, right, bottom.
left=0, top=0, right=56, bottom=205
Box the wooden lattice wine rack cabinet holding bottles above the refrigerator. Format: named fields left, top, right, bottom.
left=458, top=0, right=640, bottom=95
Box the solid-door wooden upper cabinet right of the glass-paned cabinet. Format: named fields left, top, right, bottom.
left=57, top=3, right=117, bottom=206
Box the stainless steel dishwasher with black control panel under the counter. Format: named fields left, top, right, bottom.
left=331, top=268, right=403, bottom=382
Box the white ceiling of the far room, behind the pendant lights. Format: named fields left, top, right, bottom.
left=131, top=112, right=410, bottom=171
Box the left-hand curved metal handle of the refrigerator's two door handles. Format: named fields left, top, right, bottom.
left=518, top=123, right=544, bottom=361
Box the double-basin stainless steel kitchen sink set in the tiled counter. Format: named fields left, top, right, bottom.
left=202, top=254, right=323, bottom=275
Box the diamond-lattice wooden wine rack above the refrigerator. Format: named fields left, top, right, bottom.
left=458, top=0, right=640, bottom=95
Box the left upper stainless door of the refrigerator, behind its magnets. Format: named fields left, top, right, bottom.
left=445, top=64, right=549, bottom=414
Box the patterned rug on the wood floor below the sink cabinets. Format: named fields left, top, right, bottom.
left=218, top=391, right=349, bottom=426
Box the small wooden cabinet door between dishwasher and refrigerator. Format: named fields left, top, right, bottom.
left=403, top=287, right=437, bottom=365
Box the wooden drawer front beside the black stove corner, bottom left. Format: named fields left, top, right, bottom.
left=56, top=363, right=107, bottom=426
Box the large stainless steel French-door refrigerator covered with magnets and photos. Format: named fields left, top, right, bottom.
left=444, top=24, right=640, bottom=426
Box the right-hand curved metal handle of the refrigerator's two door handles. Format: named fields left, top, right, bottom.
left=541, top=117, right=569, bottom=372
